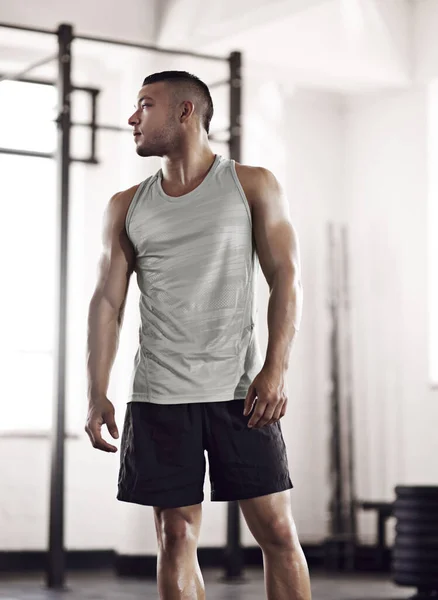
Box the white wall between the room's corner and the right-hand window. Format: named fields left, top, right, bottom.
left=345, top=87, right=438, bottom=540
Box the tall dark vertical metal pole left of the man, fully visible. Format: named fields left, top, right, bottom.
left=47, top=25, right=73, bottom=589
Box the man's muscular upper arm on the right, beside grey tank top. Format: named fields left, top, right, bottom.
left=252, top=170, right=300, bottom=284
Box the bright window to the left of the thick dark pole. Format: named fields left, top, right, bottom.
left=0, top=81, right=57, bottom=432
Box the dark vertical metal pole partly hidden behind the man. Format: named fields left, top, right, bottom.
left=224, top=52, right=244, bottom=581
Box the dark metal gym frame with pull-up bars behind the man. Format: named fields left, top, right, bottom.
left=0, top=23, right=244, bottom=589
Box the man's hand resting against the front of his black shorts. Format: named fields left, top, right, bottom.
left=243, top=367, right=287, bottom=429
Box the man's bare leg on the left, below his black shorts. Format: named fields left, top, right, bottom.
left=154, top=504, right=205, bottom=600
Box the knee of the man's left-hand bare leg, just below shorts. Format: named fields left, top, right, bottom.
left=154, top=507, right=200, bottom=552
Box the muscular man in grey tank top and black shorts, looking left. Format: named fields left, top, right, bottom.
left=86, top=71, right=311, bottom=600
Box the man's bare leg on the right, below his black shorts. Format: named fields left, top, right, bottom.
left=240, top=490, right=311, bottom=600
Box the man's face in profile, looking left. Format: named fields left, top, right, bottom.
left=128, top=81, right=178, bottom=156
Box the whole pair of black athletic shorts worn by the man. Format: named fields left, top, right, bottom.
left=117, top=400, right=292, bottom=508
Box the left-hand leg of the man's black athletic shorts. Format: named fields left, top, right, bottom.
left=117, top=402, right=205, bottom=508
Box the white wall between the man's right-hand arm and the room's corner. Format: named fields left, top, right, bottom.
left=250, top=82, right=344, bottom=543
